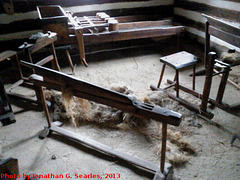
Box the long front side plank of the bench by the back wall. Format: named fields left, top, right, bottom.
left=84, top=26, right=185, bottom=43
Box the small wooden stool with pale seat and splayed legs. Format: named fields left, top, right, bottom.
left=157, top=51, right=198, bottom=97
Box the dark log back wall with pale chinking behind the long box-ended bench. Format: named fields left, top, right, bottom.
left=0, top=0, right=174, bottom=50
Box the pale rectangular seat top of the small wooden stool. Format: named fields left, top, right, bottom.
left=160, top=51, right=198, bottom=69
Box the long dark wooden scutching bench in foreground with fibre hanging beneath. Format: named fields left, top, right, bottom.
left=21, top=61, right=182, bottom=179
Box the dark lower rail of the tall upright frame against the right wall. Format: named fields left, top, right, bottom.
left=209, top=26, right=240, bottom=47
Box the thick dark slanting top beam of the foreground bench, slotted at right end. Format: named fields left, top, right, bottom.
left=24, top=61, right=181, bottom=126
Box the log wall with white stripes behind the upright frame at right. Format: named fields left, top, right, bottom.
left=174, top=0, right=240, bottom=52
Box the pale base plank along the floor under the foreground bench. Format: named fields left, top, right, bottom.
left=51, top=125, right=166, bottom=177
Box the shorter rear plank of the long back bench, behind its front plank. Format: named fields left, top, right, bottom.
left=118, top=20, right=172, bottom=30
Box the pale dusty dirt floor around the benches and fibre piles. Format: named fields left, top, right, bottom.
left=0, top=41, right=240, bottom=180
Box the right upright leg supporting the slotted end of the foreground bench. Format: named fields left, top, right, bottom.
left=160, top=123, right=167, bottom=174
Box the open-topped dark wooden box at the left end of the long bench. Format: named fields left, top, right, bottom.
left=37, top=5, right=69, bottom=38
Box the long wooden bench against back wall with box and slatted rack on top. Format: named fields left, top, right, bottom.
left=37, top=5, right=185, bottom=66
